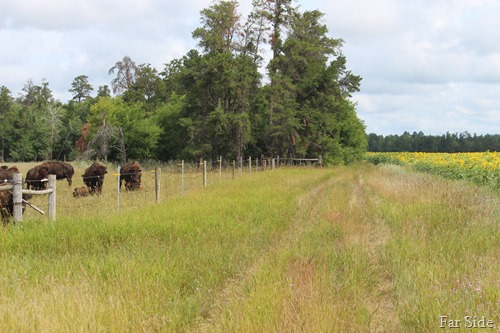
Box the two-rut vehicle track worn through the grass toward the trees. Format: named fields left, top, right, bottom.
left=192, top=166, right=401, bottom=332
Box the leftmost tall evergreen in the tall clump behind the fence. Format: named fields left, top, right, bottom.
left=175, top=1, right=260, bottom=159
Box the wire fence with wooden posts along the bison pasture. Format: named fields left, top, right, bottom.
left=14, top=158, right=321, bottom=221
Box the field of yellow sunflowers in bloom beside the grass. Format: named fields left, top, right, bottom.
left=365, top=151, right=500, bottom=191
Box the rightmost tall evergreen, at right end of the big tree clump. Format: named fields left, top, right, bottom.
left=256, top=11, right=366, bottom=163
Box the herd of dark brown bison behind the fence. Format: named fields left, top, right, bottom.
left=0, top=162, right=142, bottom=222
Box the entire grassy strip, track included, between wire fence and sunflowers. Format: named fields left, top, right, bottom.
left=0, top=165, right=500, bottom=332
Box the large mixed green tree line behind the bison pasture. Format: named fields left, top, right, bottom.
left=0, top=0, right=367, bottom=163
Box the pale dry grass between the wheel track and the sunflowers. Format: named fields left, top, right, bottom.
left=373, top=167, right=500, bottom=332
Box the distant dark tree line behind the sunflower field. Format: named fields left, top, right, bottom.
left=368, top=132, right=500, bottom=153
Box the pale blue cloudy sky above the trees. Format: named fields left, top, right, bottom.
left=0, top=0, right=500, bottom=135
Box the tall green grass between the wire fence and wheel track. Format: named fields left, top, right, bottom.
left=0, top=171, right=332, bottom=331
